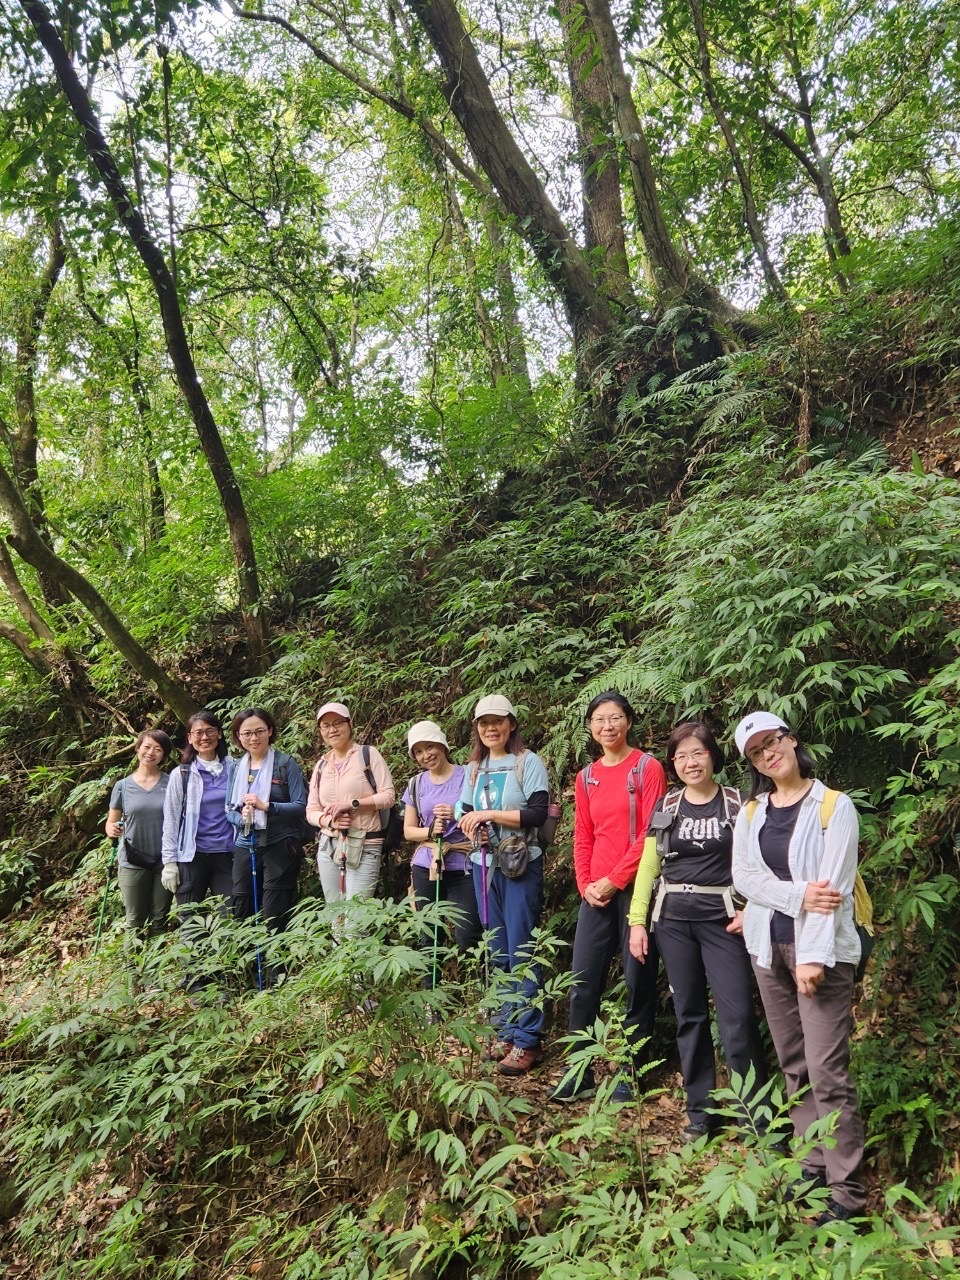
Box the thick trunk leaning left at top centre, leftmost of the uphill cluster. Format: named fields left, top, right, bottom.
left=403, top=0, right=613, bottom=347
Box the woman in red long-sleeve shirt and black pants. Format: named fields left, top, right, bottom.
left=550, top=690, right=667, bottom=1102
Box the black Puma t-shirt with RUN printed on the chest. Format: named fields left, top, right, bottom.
left=658, top=790, right=733, bottom=920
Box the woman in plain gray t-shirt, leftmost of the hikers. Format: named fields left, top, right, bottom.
left=105, top=728, right=173, bottom=933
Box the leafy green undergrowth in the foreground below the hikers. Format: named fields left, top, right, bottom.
left=0, top=904, right=952, bottom=1280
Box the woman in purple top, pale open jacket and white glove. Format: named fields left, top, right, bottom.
left=161, top=712, right=234, bottom=993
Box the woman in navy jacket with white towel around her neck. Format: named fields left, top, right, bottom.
left=227, top=707, right=307, bottom=933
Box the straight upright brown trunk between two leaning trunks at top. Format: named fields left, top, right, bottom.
left=558, top=0, right=636, bottom=306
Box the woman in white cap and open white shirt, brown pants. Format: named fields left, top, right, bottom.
left=733, top=712, right=867, bottom=1226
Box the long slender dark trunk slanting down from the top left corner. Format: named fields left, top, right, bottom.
left=20, top=0, right=268, bottom=666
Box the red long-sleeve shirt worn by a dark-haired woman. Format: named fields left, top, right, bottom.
left=573, top=750, right=667, bottom=897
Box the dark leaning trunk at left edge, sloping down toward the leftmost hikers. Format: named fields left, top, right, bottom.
left=0, top=463, right=200, bottom=721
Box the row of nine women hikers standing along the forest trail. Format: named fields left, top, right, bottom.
left=106, top=690, right=865, bottom=1225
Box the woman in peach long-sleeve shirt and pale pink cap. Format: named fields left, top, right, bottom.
left=307, top=703, right=397, bottom=902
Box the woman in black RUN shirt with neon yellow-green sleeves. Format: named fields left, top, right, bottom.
left=630, top=722, right=767, bottom=1142
